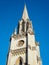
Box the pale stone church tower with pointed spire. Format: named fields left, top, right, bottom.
left=6, top=5, right=42, bottom=65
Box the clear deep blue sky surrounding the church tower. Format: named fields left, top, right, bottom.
left=0, top=0, right=49, bottom=65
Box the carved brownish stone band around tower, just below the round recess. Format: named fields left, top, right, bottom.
left=10, top=46, right=36, bottom=55
